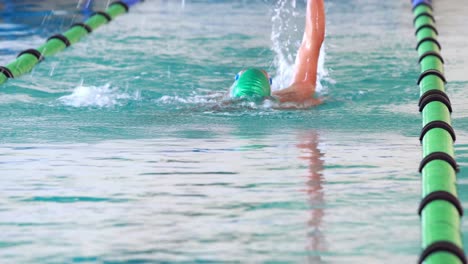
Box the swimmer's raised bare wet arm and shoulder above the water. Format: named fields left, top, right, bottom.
left=273, top=0, right=325, bottom=107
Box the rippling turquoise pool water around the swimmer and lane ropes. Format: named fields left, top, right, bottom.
left=0, top=0, right=468, bottom=263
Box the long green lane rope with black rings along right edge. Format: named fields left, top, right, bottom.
left=411, top=0, right=467, bottom=264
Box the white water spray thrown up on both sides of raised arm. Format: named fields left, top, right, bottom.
left=271, top=0, right=332, bottom=92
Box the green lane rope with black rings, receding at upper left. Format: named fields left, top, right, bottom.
left=0, top=0, right=143, bottom=84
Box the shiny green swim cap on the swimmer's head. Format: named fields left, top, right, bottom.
left=231, top=68, right=271, bottom=99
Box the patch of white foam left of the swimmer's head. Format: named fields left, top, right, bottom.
left=58, top=84, right=140, bottom=107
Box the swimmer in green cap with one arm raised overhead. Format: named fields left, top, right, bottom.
left=230, top=0, right=325, bottom=108
